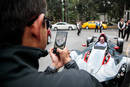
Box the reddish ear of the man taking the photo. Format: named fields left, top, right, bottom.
left=31, top=14, right=44, bottom=40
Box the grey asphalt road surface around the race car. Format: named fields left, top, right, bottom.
left=39, top=29, right=130, bottom=71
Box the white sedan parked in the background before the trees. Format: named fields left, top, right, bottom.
left=51, top=22, right=77, bottom=30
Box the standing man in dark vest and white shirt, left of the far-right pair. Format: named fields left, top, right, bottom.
left=118, top=18, right=125, bottom=38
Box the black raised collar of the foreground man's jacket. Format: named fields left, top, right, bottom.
left=0, top=45, right=48, bottom=69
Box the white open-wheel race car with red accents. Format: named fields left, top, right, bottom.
left=70, top=34, right=130, bottom=87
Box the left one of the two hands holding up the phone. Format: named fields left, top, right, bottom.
left=49, top=48, right=64, bottom=69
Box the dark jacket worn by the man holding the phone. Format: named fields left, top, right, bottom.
left=0, top=46, right=102, bottom=87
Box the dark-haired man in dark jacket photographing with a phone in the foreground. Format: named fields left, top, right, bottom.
left=0, top=0, right=102, bottom=87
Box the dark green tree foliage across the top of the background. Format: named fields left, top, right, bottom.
left=47, top=0, right=130, bottom=22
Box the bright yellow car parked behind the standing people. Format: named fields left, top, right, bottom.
left=82, top=21, right=107, bottom=29
